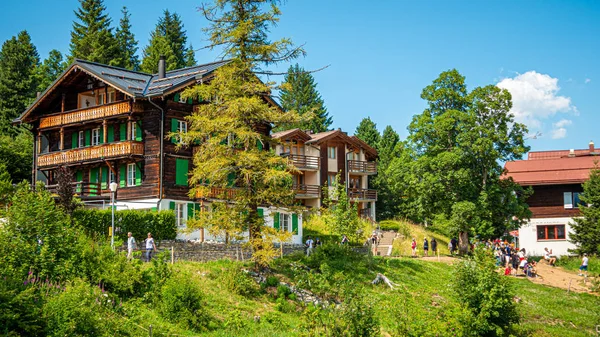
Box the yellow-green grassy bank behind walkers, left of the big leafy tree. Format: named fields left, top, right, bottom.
left=380, top=220, right=450, bottom=256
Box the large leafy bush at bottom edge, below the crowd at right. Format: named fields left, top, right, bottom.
left=452, top=248, right=519, bottom=336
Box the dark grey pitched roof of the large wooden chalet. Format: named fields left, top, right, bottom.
left=14, top=59, right=230, bottom=122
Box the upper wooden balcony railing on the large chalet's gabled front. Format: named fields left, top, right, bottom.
left=40, top=101, right=143, bottom=129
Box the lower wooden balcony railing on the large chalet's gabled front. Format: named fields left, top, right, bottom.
left=37, top=141, right=144, bottom=167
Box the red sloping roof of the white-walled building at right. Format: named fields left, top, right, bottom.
left=504, top=151, right=600, bottom=186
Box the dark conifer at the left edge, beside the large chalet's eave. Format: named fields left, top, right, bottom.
left=0, top=31, right=40, bottom=136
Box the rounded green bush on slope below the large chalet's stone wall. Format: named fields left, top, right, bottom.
left=158, top=275, right=210, bottom=331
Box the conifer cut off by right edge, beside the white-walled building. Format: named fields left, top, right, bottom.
left=569, top=167, right=600, bottom=254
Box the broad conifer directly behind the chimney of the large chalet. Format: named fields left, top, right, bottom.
left=140, top=10, right=191, bottom=74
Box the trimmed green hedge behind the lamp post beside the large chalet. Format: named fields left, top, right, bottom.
left=72, top=209, right=177, bottom=241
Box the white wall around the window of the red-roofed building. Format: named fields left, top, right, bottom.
left=519, top=218, right=576, bottom=256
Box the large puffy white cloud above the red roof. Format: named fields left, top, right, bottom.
left=497, top=71, right=578, bottom=129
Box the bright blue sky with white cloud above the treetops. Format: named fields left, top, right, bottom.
left=0, top=0, right=600, bottom=150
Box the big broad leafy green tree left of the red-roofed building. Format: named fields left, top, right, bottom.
left=404, top=70, right=531, bottom=253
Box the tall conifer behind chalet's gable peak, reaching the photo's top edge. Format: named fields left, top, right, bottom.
left=69, top=0, right=121, bottom=65
